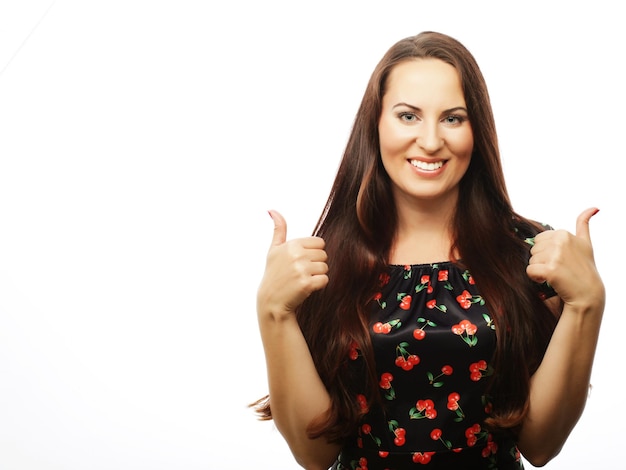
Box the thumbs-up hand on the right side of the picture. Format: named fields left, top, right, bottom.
left=526, top=208, right=604, bottom=308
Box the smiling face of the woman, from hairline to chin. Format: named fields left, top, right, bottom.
left=378, top=58, right=474, bottom=209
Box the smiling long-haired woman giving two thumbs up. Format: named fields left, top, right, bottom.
left=251, top=32, right=605, bottom=470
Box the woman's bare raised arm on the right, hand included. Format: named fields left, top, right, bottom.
left=518, top=209, right=605, bottom=466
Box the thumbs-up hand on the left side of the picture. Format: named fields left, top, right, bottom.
left=257, top=211, right=328, bottom=317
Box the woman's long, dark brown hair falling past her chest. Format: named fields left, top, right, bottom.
left=251, top=32, right=556, bottom=442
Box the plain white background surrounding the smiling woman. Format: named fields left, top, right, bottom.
left=0, top=0, right=626, bottom=470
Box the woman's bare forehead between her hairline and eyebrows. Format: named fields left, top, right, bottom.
left=383, top=58, right=465, bottom=107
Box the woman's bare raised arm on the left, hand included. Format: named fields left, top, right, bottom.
left=257, top=211, right=339, bottom=470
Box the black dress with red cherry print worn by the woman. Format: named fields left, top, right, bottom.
left=333, top=229, right=555, bottom=470
